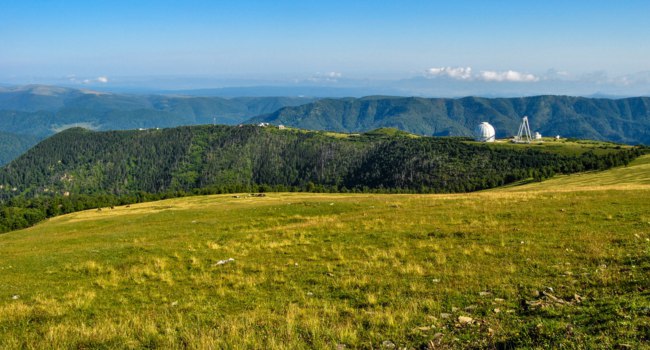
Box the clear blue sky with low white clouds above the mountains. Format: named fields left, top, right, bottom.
left=0, top=0, right=650, bottom=96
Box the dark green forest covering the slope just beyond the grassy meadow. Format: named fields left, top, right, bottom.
left=0, top=125, right=642, bottom=231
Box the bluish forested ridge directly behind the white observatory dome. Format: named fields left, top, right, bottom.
left=250, top=96, right=650, bottom=145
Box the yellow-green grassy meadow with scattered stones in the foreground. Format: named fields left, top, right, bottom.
left=0, top=156, right=650, bottom=349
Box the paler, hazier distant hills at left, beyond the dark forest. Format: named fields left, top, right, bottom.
left=0, top=85, right=313, bottom=165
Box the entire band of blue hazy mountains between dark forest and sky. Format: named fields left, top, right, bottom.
left=0, top=85, right=650, bottom=164
